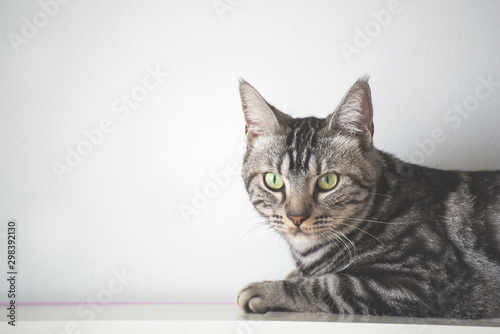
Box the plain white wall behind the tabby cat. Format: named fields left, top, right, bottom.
left=0, top=0, right=500, bottom=302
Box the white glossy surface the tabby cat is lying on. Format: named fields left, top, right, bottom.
left=0, top=305, right=500, bottom=334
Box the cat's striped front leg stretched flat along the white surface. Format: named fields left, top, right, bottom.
left=238, top=273, right=428, bottom=316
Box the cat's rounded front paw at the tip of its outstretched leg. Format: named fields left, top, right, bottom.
left=238, top=281, right=283, bottom=313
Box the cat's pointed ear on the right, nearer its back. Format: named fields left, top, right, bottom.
left=327, top=78, right=374, bottom=143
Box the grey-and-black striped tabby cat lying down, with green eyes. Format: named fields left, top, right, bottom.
left=237, top=78, right=500, bottom=319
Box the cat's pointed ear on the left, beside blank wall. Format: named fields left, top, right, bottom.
left=240, top=79, right=291, bottom=140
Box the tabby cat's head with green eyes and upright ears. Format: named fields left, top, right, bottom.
left=240, top=79, right=378, bottom=247
